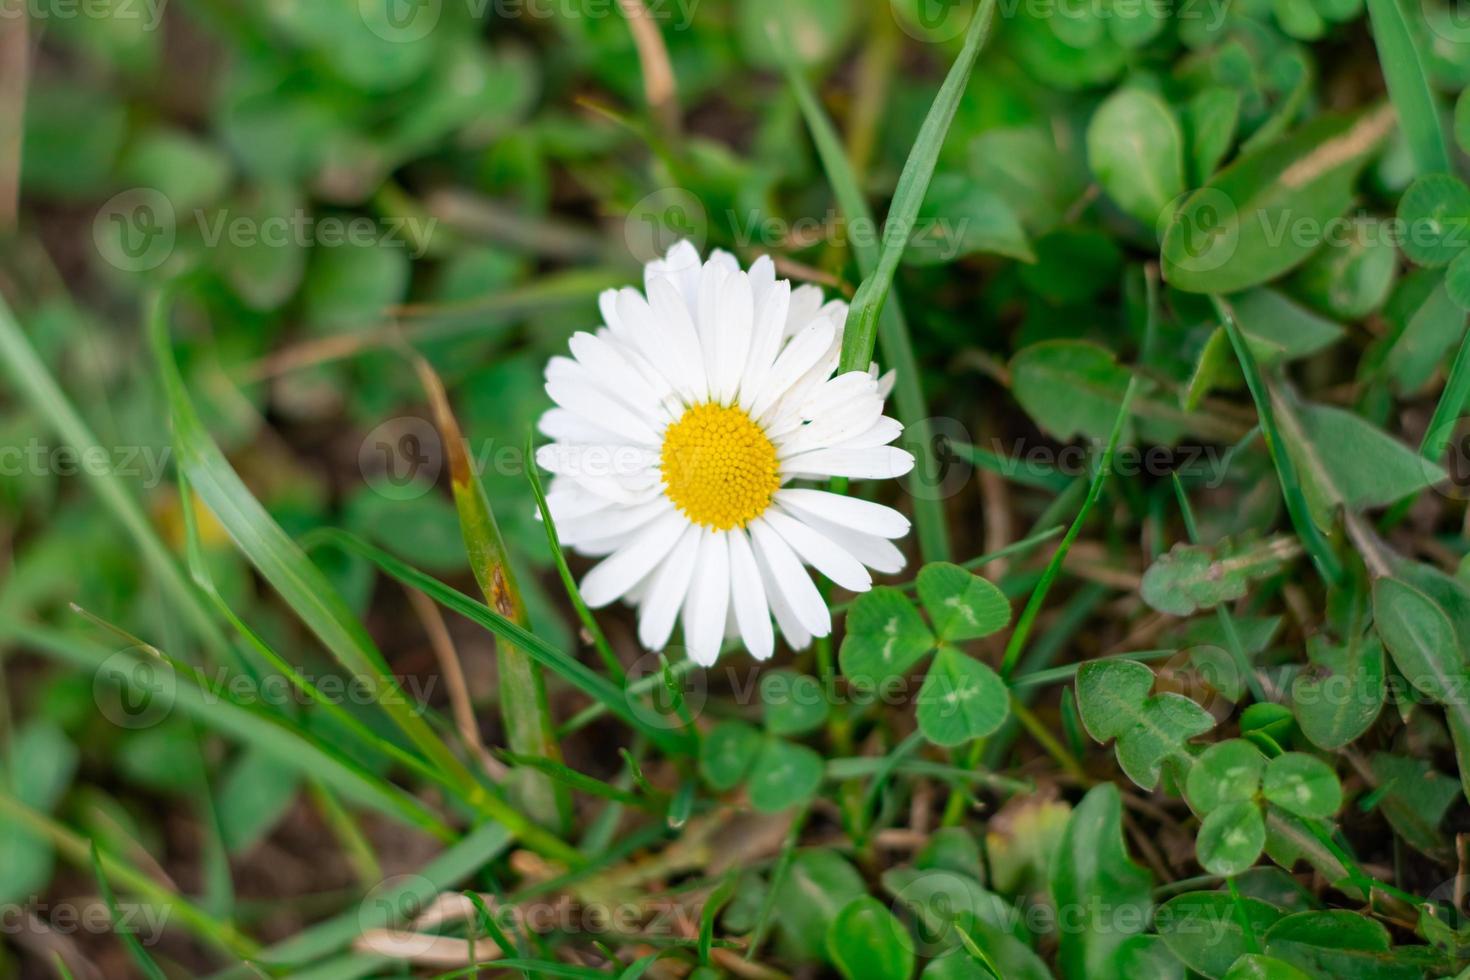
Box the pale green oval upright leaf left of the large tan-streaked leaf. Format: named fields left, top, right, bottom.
left=1088, top=88, right=1185, bottom=228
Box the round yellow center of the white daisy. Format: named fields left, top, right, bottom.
left=660, top=403, right=781, bottom=530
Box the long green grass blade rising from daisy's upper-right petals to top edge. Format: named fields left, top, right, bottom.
left=838, top=0, right=995, bottom=372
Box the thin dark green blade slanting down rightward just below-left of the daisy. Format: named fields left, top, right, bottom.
left=310, top=529, right=692, bottom=755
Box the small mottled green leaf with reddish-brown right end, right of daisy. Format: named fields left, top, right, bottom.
left=1139, top=538, right=1298, bottom=616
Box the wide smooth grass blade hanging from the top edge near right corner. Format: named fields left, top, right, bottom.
left=1367, top=0, right=1451, bottom=175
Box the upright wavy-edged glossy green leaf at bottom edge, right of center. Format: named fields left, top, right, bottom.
left=1051, top=783, right=1154, bottom=980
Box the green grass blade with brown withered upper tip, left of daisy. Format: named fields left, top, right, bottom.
left=412, top=354, right=572, bottom=827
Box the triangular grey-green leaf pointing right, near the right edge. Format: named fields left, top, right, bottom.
left=1273, top=397, right=1446, bottom=527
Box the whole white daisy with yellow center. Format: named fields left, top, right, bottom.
left=537, top=242, right=913, bottom=666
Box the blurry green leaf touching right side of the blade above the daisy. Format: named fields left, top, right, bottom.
left=904, top=173, right=1036, bottom=266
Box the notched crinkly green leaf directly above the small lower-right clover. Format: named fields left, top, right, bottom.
left=1291, top=632, right=1386, bottom=751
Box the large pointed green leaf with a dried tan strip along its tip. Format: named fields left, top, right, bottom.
left=1163, top=110, right=1394, bottom=294
